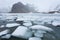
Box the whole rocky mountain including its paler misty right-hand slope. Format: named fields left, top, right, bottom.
left=10, top=2, right=36, bottom=13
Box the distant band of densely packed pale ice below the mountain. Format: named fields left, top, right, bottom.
left=0, top=13, right=60, bottom=20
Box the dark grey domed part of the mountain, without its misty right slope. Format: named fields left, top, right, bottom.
left=11, top=2, right=29, bottom=13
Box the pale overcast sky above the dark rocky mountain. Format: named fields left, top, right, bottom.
left=0, top=0, right=60, bottom=12
